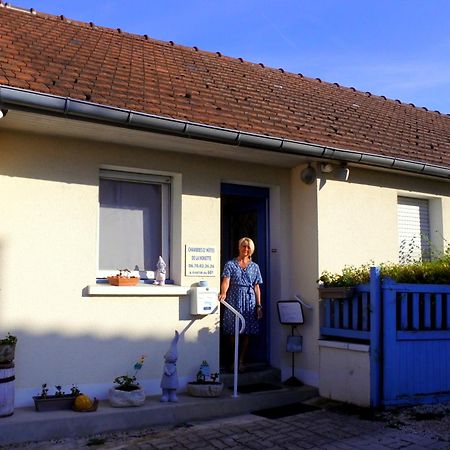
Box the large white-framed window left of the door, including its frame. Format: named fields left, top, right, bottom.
left=98, top=170, right=171, bottom=279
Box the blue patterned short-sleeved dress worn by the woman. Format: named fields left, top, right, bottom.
left=222, top=259, right=263, bottom=334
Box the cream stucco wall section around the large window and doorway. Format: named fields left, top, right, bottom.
left=0, top=127, right=290, bottom=406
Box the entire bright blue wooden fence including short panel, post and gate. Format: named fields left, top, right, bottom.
left=320, top=268, right=450, bottom=406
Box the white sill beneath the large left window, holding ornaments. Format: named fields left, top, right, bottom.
left=86, top=283, right=190, bottom=297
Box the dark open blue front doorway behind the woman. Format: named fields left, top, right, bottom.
left=221, top=183, right=270, bottom=366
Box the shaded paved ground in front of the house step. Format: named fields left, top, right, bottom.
left=3, top=400, right=450, bottom=450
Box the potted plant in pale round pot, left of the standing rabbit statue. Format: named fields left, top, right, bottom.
left=108, top=356, right=145, bottom=408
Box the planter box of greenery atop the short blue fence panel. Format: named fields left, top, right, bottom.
left=317, top=265, right=370, bottom=298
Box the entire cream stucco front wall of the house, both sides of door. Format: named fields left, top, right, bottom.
left=0, top=119, right=450, bottom=405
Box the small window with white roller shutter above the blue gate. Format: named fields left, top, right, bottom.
left=397, top=197, right=431, bottom=264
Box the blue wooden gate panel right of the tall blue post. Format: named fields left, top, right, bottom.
left=381, top=279, right=450, bottom=405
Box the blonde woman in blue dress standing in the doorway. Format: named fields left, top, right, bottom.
left=219, top=237, right=263, bottom=372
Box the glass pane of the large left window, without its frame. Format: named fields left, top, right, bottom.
left=99, top=179, right=162, bottom=270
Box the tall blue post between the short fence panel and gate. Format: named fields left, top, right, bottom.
left=370, top=267, right=382, bottom=408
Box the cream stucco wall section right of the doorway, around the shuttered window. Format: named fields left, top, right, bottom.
left=288, top=165, right=450, bottom=394
